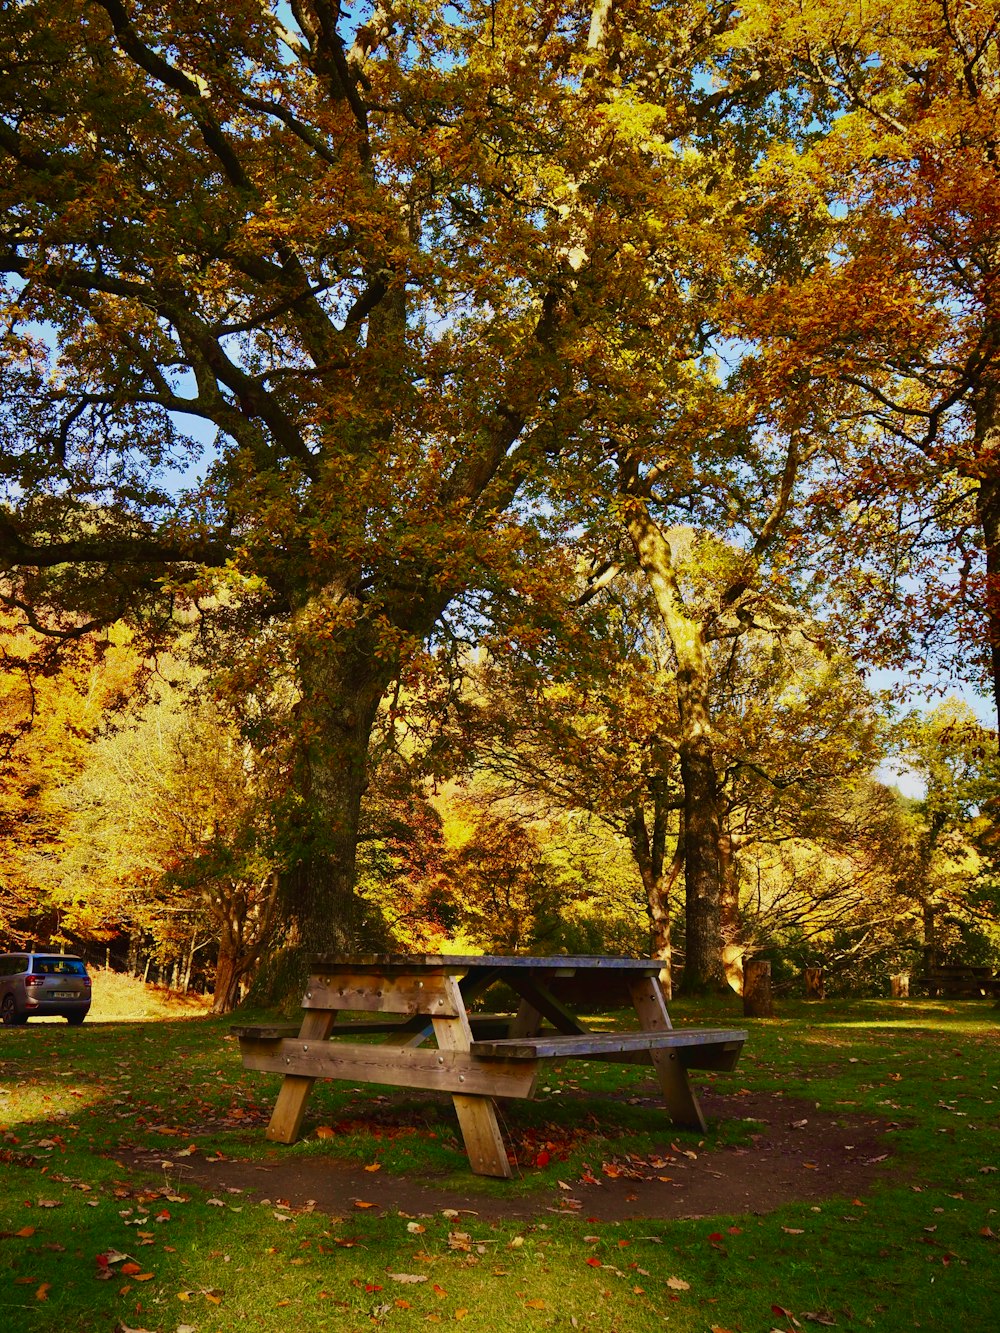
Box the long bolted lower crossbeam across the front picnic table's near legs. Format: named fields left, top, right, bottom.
left=240, top=1037, right=537, bottom=1097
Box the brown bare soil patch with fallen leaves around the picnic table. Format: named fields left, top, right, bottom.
left=115, top=1090, right=893, bottom=1222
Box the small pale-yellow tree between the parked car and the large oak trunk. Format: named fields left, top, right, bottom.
left=49, top=686, right=281, bottom=1013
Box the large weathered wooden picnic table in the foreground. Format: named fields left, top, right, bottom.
left=232, top=954, right=747, bottom=1177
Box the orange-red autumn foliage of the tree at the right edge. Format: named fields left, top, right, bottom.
left=752, top=0, right=1000, bottom=730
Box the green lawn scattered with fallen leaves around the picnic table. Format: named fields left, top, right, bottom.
left=0, top=1001, right=1000, bottom=1333
